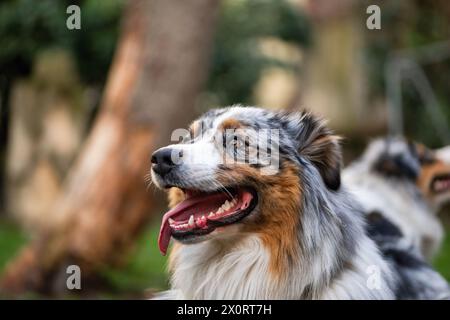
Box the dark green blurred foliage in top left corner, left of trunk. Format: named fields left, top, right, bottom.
left=0, top=0, right=124, bottom=83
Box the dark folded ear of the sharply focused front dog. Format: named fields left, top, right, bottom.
left=291, top=113, right=342, bottom=190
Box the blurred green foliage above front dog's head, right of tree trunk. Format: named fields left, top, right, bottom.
left=208, top=0, right=311, bottom=105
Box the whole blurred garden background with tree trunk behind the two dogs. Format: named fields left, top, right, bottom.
left=0, top=0, right=450, bottom=298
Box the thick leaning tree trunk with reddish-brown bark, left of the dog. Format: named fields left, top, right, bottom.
left=1, top=0, right=218, bottom=294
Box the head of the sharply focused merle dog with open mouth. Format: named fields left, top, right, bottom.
left=151, top=107, right=341, bottom=253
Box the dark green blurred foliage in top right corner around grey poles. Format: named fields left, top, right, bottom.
left=364, top=0, right=450, bottom=147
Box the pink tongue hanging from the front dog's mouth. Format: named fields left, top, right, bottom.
left=158, top=193, right=228, bottom=255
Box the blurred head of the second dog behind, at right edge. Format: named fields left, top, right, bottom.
left=366, top=138, right=450, bottom=209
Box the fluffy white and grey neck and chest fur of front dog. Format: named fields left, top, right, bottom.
left=167, top=174, right=393, bottom=299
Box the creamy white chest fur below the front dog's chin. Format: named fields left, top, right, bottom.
left=171, top=237, right=292, bottom=299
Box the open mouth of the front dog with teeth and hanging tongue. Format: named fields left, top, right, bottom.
left=158, top=188, right=257, bottom=254
